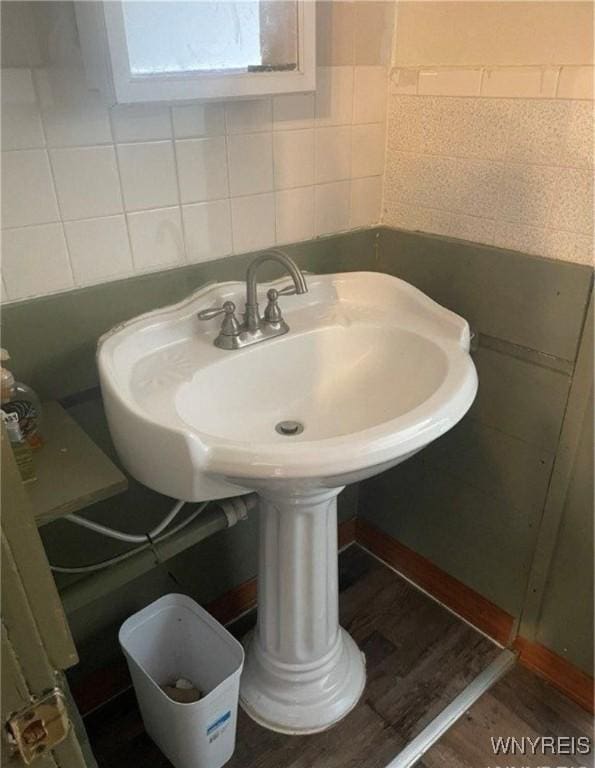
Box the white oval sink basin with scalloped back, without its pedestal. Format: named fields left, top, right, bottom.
left=98, top=272, right=477, bottom=501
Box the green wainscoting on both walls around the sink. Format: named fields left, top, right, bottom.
left=3, top=228, right=592, bottom=682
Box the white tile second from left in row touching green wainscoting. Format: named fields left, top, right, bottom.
left=64, top=215, right=133, bottom=285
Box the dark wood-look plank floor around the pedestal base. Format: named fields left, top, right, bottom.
left=85, top=545, right=590, bottom=768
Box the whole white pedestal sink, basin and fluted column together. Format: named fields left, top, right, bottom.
left=98, top=272, right=477, bottom=733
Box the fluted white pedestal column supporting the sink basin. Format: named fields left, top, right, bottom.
left=240, top=488, right=366, bottom=733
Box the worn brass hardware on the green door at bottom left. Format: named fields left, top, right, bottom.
left=6, top=688, right=70, bottom=765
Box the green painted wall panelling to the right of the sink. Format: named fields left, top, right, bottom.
left=359, top=230, right=593, bottom=676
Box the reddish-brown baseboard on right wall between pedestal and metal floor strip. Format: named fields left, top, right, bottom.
left=355, top=519, right=514, bottom=646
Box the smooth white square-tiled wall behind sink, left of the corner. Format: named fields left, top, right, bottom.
left=2, top=64, right=386, bottom=301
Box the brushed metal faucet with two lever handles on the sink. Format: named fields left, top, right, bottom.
left=198, top=249, right=308, bottom=349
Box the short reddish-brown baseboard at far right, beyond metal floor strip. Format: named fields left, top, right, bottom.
left=513, top=636, right=595, bottom=713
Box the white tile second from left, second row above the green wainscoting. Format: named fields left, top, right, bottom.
left=50, top=147, right=122, bottom=219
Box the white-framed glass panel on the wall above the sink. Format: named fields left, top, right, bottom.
left=77, top=0, right=315, bottom=103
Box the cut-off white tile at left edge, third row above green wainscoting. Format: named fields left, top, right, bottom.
left=1, top=67, right=45, bottom=150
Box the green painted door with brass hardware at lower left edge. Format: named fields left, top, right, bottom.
left=0, top=429, right=96, bottom=768
